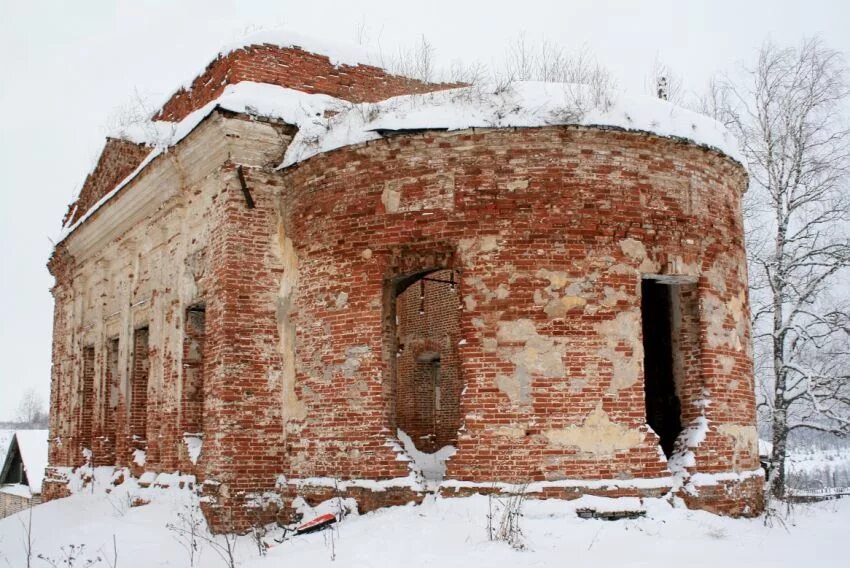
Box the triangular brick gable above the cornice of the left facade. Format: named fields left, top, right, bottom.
left=63, top=138, right=151, bottom=225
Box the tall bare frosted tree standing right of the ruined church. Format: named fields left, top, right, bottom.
left=720, top=39, right=850, bottom=497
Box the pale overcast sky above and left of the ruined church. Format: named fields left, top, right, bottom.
left=0, top=0, right=850, bottom=420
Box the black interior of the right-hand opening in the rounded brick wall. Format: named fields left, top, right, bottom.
left=641, top=278, right=682, bottom=457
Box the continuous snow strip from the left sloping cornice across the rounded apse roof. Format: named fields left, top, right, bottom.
left=56, top=81, right=743, bottom=242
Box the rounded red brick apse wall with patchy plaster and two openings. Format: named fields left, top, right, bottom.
left=282, top=127, right=758, bottom=496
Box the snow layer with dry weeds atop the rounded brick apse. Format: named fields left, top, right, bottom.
left=281, top=81, right=743, bottom=167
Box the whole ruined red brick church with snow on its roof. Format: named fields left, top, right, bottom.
left=44, top=32, right=764, bottom=530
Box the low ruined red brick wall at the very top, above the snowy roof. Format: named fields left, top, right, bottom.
left=155, top=44, right=457, bottom=121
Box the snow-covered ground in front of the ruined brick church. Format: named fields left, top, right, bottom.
left=0, top=471, right=850, bottom=568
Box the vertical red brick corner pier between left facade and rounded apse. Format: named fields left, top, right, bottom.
left=201, top=164, right=288, bottom=526
